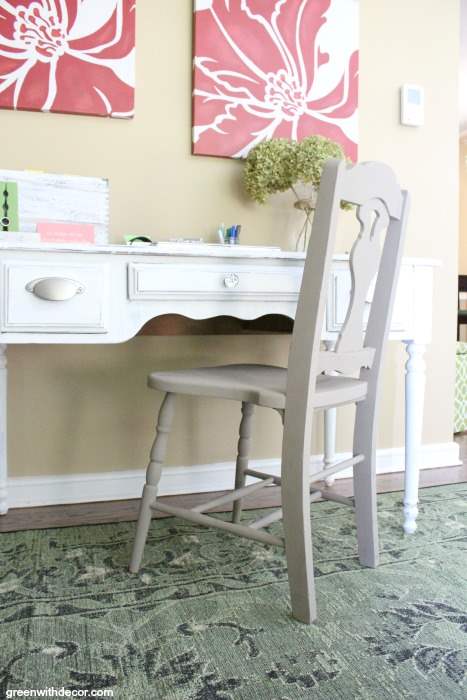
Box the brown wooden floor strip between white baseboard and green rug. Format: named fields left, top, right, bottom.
left=0, top=433, right=467, bottom=532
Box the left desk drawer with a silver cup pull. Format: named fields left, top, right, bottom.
left=1, top=262, right=108, bottom=333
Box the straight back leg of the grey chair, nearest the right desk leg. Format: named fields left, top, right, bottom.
left=353, top=402, right=379, bottom=568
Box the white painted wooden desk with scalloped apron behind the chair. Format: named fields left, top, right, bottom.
left=0, top=243, right=436, bottom=533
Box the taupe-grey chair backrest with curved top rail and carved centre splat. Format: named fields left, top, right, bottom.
left=286, top=160, right=408, bottom=432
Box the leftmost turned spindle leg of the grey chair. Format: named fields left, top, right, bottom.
left=129, top=394, right=175, bottom=573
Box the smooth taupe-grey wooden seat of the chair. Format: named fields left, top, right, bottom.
left=148, top=365, right=367, bottom=409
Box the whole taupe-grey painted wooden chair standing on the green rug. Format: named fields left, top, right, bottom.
left=130, top=160, right=408, bottom=623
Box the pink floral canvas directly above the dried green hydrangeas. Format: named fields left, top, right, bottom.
left=193, top=0, right=358, bottom=160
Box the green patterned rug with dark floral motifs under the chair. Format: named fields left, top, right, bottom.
left=0, top=484, right=467, bottom=700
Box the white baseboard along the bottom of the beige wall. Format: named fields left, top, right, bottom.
left=8, top=442, right=460, bottom=508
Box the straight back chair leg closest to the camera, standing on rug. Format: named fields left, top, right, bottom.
left=281, top=410, right=317, bottom=624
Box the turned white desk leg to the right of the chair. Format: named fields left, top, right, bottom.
left=404, top=340, right=426, bottom=535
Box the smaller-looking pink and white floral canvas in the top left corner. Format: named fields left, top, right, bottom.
left=0, top=0, right=135, bottom=117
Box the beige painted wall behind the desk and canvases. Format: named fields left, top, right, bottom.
left=0, top=0, right=459, bottom=476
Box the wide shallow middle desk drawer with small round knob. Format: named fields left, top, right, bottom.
left=128, top=261, right=302, bottom=301
